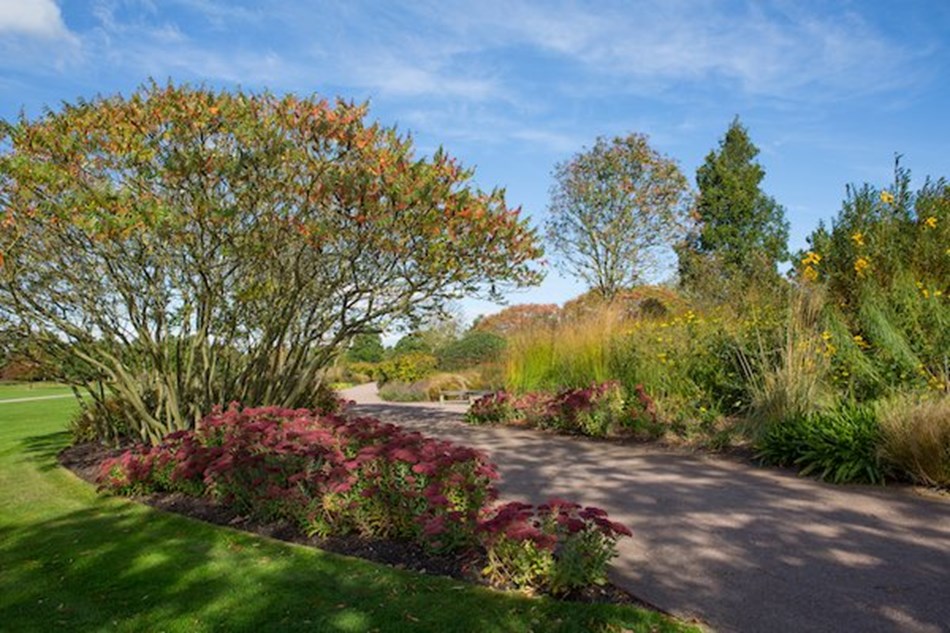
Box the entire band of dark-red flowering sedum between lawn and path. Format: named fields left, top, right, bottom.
left=99, top=405, right=629, bottom=594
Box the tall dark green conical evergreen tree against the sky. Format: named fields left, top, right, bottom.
left=679, top=117, right=788, bottom=292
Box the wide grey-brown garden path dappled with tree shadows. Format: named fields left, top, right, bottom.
left=344, top=385, right=950, bottom=633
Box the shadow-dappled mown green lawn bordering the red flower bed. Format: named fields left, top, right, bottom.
left=0, top=386, right=695, bottom=632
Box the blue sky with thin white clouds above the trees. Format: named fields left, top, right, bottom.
left=0, top=0, right=950, bottom=318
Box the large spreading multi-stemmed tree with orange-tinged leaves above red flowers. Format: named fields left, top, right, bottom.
left=0, top=83, right=540, bottom=439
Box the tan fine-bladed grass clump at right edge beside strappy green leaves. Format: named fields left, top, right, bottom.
left=881, top=396, right=950, bottom=488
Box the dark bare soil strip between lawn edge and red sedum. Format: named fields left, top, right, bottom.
left=58, top=442, right=665, bottom=613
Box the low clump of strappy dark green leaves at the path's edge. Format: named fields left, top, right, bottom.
left=757, top=404, right=888, bottom=483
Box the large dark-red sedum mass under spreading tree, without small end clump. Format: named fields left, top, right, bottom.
left=100, top=406, right=497, bottom=549
